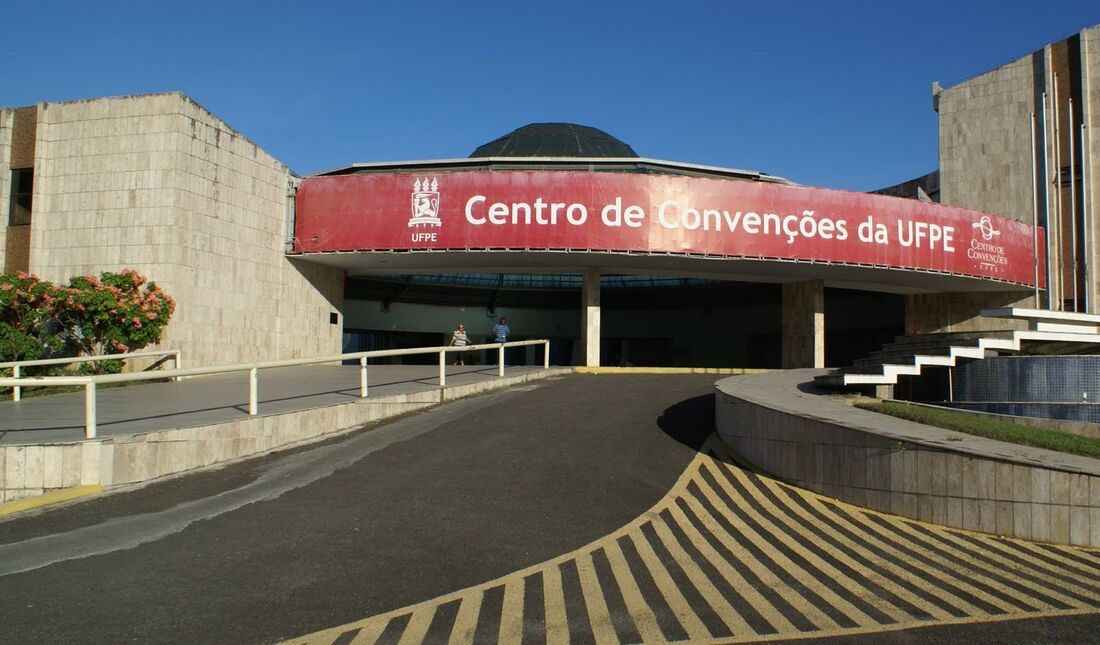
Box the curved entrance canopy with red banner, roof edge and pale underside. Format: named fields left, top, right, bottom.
left=294, top=157, right=1045, bottom=293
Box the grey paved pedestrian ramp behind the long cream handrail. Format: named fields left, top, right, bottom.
left=0, top=365, right=542, bottom=445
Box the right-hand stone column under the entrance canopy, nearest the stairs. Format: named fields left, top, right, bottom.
left=782, top=280, right=825, bottom=370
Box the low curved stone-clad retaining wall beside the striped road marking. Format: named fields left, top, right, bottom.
left=715, top=370, right=1100, bottom=547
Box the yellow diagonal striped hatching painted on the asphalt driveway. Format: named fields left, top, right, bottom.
left=281, top=437, right=1100, bottom=644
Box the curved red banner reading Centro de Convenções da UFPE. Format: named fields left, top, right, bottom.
left=295, top=171, right=1045, bottom=286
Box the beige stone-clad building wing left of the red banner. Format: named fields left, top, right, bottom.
left=0, top=92, right=343, bottom=364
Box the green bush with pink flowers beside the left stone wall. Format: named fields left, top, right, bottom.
left=0, top=269, right=176, bottom=373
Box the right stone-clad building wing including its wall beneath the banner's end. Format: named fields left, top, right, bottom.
left=928, top=25, right=1100, bottom=330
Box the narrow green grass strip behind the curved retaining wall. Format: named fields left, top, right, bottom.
left=855, top=401, right=1100, bottom=459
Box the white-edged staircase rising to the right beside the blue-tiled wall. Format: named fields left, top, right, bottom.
left=814, top=307, right=1100, bottom=387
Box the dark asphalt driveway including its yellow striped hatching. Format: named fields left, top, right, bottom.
left=0, top=374, right=1100, bottom=645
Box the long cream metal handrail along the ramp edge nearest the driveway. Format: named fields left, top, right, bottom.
left=0, top=339, right=550, bottom=439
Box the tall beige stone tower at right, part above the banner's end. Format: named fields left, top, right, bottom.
left=934, top=25, right=1100, bottom=310
